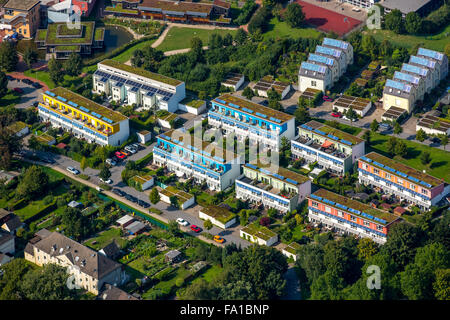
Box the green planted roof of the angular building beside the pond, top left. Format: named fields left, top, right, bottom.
left=45, top=21, right=95, bottom=45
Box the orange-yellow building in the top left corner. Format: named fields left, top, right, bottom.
left=3, top=3, right=40, bottom=38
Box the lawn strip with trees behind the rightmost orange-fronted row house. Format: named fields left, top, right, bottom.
left=366, top=133, right=450, bottom=183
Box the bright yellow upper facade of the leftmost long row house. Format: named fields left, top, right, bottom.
left=40, top=93, right=120, bottom=135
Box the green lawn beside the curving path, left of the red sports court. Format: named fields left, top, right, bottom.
left=156, top=27, right=236, bottom=51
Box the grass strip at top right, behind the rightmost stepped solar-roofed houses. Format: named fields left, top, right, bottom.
left=365, top=25, right=450, bottom=52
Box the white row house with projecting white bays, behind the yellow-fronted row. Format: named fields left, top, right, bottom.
left=92, top=60, right=187, bottom=113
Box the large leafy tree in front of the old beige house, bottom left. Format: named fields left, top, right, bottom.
left=21, top=263, right=72, bottom=300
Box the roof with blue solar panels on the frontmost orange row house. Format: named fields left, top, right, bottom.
left=310, top=189, right=398, bottom=225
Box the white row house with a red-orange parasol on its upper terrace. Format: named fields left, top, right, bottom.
left=291, top=120, right=365, bottom=175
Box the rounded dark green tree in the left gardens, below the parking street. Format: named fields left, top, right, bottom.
left=16, top=165, right=49, bottom=199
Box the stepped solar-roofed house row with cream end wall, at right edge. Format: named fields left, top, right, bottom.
left=383, top=48, right=448, bottom=113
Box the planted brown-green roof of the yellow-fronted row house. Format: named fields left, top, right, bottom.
left=50, top=87, right=128, bottom=123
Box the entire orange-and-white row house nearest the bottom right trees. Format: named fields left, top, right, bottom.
left=307, top=189, right=402, bottom=244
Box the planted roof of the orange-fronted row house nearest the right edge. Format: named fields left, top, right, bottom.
left=359, top=152, right=444, bottom=187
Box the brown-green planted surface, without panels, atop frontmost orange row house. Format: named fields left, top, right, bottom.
left=311, top=189, right=398, bottom=225
